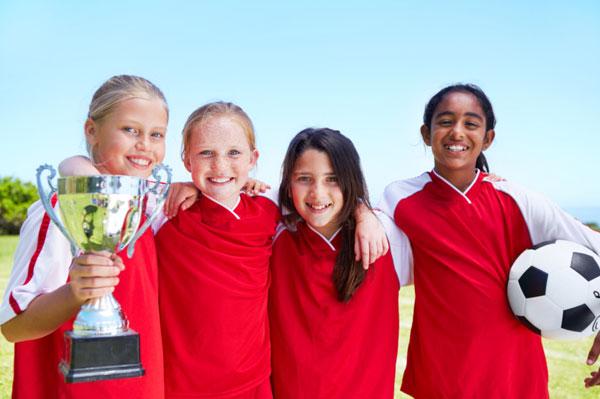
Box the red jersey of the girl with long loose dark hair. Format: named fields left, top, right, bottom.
left=269, top=222, right=410, bottom=399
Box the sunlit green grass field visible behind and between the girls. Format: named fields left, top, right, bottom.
left=0, top=236, right=600, bottom=399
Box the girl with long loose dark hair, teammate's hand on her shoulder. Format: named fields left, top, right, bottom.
left=269, top=129, right=410, bottom=399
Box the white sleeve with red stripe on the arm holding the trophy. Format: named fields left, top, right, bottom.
left=0, top=200, right=73, bottom=324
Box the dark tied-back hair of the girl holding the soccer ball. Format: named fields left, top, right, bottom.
left=423, top=83, right=496, bottom=172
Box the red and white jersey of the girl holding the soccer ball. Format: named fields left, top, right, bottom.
left=380, top=172, right=600, bottom=398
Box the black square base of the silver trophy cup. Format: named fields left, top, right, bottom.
left=58, top=330, right=144, bottom=383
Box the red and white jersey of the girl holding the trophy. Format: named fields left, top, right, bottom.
left=0, top=201, right=164, bottom=399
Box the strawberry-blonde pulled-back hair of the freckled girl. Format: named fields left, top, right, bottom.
left=181, top=101, right=256, bottom=162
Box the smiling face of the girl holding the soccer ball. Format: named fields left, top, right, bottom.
left=421, top=91, right=494, bottom=190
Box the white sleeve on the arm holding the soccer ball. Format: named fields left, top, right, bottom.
left=493, top=182, right=600, bottom=254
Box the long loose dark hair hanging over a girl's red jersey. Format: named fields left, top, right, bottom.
left=279, top=128, right=371, bottom=302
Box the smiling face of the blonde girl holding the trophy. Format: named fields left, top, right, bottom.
left=85, top=98, right=168, bottom=178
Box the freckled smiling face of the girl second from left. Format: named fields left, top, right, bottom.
left=184, top=115, right=258, bottom=208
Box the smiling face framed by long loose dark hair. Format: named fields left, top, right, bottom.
left=291, top=149, right=344, bottom=238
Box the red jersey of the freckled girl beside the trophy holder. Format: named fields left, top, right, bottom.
left=156, top=194, right=280, bottom=398
